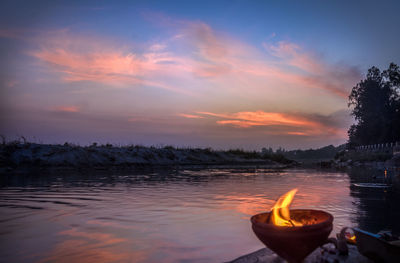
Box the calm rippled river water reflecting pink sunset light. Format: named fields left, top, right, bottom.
left=0, top=168, right=400, bottom=263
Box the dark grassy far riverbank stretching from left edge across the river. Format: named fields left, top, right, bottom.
left=0, top=142, right=296, bottom=169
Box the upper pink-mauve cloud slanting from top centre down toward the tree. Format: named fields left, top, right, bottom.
left=178, top=22, right=360, bottom=98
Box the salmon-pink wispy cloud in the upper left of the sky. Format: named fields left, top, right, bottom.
left=31, top=48, right=191, bottom=94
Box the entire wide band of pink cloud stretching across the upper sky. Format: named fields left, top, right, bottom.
left=31, top=20, right=360, bottom=101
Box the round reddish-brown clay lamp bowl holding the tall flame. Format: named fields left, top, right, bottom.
left=251, top=209, right=333, bottom=262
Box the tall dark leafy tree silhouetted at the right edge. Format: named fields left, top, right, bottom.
left=348, top=63, right=400, bottom=146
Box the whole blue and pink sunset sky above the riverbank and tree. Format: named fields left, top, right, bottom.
left=0, top=0, right=400, bottom=150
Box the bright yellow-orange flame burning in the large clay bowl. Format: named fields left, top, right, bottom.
left=271, top=188, right=303, bottom=226
